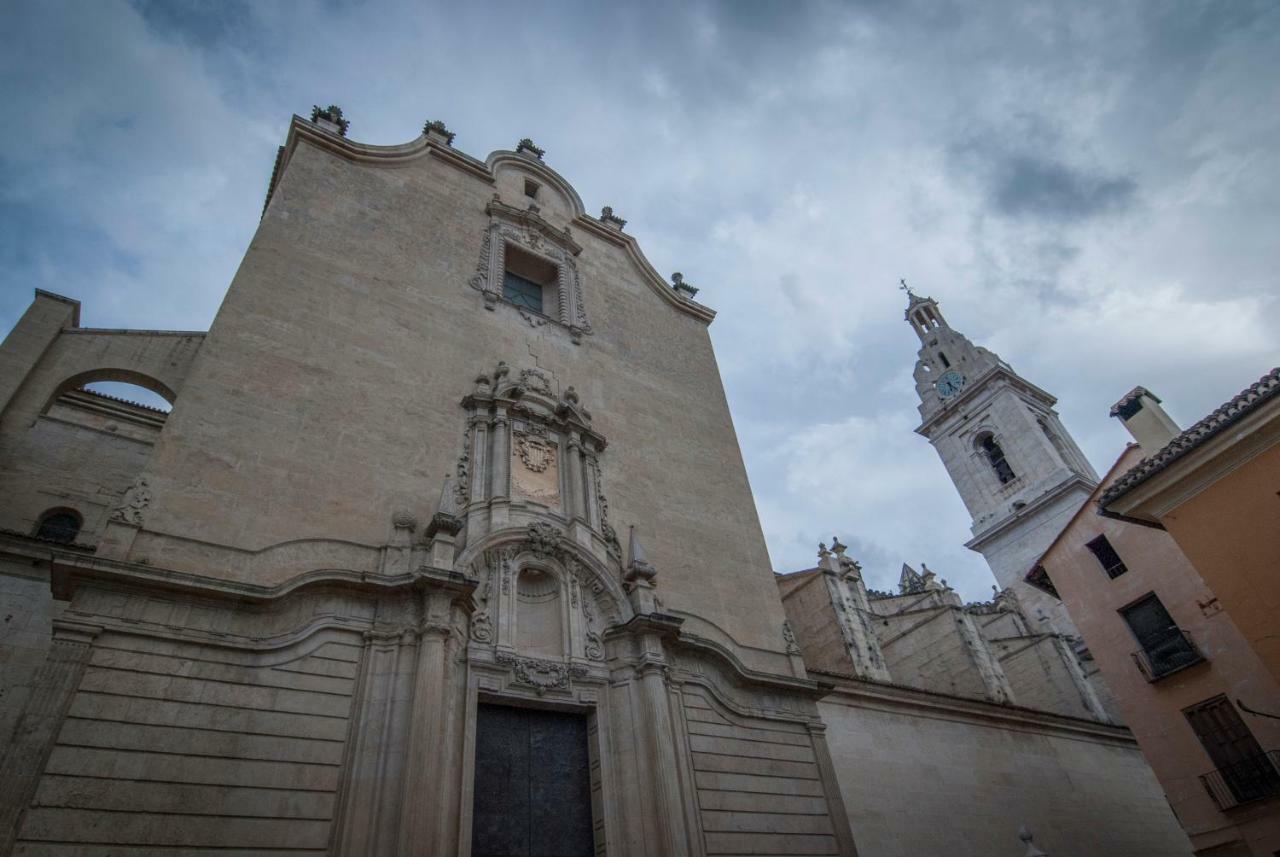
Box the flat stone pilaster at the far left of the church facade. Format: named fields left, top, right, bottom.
left=0, top=619, right=102, bottom=854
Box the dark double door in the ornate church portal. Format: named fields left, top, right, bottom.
left=471, top=705, right=594, bottom=857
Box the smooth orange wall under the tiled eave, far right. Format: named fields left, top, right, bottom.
left=1162, top=446, right=1280, bottom=679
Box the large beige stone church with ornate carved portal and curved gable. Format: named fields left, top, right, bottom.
left=0, top=109, right=1189, bottom=857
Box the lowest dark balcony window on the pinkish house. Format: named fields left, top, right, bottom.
left=1183, top=696, right=1280, bottom=810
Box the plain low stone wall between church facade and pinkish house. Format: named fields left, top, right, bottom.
left=819, top=679, right=1190, bottom=857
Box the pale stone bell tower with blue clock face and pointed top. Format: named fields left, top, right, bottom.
left=904, top=289, right=1098, bottom=634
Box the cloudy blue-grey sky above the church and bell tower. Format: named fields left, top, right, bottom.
left=0, top=0, right=1280, bottom=597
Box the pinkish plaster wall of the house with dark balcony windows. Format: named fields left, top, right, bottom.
left=1042, top=446, right=1280, bottom=854
